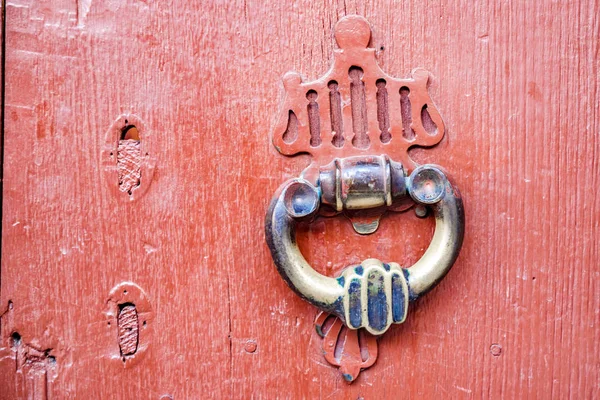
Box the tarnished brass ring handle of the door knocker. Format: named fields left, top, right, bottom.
left=266, top=156, right=464, bottom=335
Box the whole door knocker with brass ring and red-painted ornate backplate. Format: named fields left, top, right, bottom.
left=266, top=16, right=464, bottom=381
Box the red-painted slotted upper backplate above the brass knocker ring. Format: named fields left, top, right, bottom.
left=273, top=16, right=445, bottom=168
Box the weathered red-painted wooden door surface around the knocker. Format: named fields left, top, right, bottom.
left=0, top=0, right=600, bottom=399
